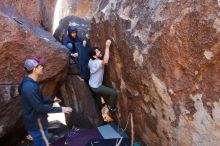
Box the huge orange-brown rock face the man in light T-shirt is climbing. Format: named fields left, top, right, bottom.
left=91, top=0, right=220, bottom=146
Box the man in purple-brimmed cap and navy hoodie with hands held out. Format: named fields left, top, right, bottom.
left=18, top=59, right=72, bottom=146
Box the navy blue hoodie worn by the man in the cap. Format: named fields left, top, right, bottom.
left=18, top=77, right=62, bottom=131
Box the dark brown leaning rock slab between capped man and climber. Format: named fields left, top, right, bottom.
left=60, top=75, right=103, bottom=128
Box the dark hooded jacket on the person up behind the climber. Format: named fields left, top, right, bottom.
left=62, top=26, right=83, bottom=53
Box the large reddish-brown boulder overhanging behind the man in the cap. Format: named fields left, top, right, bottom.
left=0, top=12, right=68, bottom=146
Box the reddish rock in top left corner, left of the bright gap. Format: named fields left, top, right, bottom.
left=0, top=0, right=56, bottom=32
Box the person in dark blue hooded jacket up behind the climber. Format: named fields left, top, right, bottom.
left=62, top=26, right=90, bottom=82
